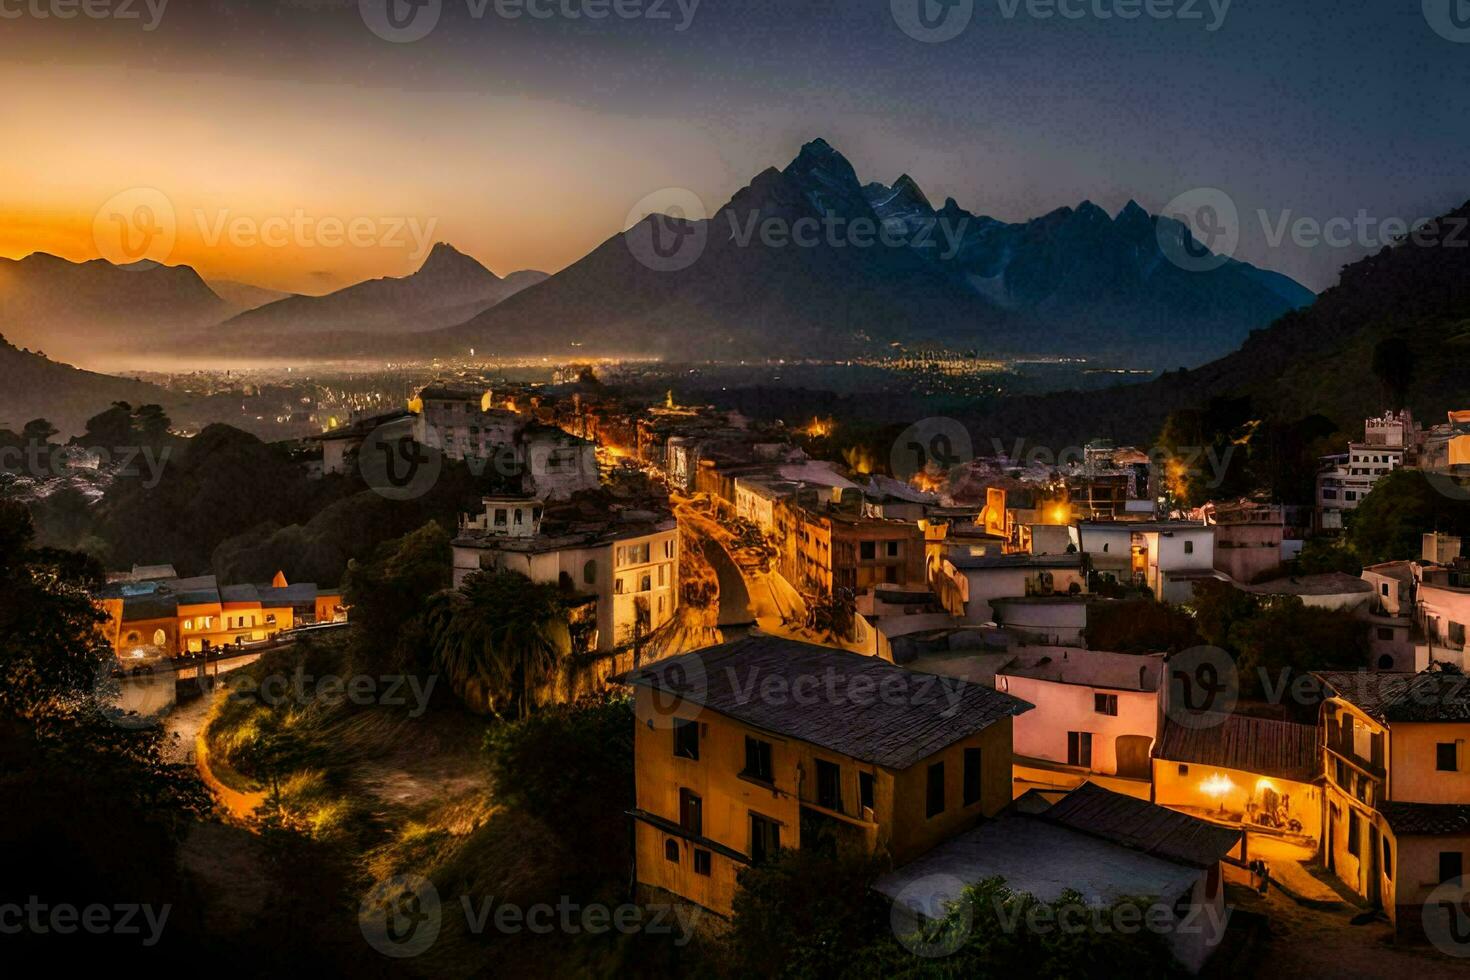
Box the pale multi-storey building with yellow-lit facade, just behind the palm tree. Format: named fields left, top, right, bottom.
left=451, top=494, right=679, bottom=652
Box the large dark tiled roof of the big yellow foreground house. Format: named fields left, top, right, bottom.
left=623, top=635, right=1033, bottom=768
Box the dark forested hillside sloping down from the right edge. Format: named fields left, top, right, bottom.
left=967, top=201, right=1470, bottom=447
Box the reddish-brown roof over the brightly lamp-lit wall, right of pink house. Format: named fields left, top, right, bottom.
left=1154, top=714, right=1320, bottom=783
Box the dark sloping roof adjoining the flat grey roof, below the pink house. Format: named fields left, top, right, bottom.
left=1041, top=782, right=1241, bottom=868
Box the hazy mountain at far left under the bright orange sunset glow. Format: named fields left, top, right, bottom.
left=0, top=251, right=235, bottom=360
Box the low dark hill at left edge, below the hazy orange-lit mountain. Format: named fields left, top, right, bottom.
left=0, top=336, right=169, bottom=437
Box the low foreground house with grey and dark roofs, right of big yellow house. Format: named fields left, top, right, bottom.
left=875, top=782, right=1241, bottom=973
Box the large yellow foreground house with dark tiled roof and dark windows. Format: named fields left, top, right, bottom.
left=625, top=635, right=1030, bottom=915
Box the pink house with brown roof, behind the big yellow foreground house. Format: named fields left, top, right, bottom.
left=995, top=646, right=1164, bottom=799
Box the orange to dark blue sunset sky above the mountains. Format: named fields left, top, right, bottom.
left=0, top=0, right=1470, bottom=292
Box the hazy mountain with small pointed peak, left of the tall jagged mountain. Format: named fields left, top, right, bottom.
left=210, top=242, right=545, bottom=347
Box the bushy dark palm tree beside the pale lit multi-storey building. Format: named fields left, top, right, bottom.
left=428, top=572, right=572, bottom=718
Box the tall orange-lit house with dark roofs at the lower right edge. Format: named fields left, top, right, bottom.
left=1317, top=670, right=1470, bottom=940
